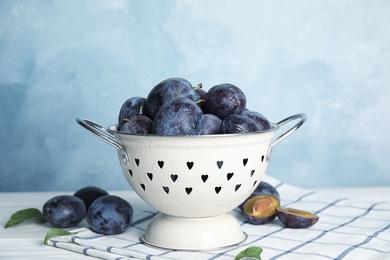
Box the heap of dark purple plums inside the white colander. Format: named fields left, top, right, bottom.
left=118, top=77, right=271, bottom=136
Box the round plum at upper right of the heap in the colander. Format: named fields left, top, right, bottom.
left=205, top=83, right=246, bottom=119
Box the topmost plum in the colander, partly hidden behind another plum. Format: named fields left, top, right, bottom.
left=146, top=77, right=199, bottom=119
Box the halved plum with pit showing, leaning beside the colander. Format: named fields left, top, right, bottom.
left=243, top=194, right=280, bottom=225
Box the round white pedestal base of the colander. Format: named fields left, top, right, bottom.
left=140, top=213, right=247, bottom=251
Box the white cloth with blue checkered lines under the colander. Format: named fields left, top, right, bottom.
left=49, top=176, right=390, bottom=260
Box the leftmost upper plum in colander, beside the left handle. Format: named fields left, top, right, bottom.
left=118, top=97, right=149, bottom=129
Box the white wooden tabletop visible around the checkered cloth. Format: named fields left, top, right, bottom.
left=0, top=187, right=390, bottom=260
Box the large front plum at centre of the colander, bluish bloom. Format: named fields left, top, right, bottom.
left=152, top=98, right=203, bottom=135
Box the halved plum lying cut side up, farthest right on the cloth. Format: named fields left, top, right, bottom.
left=276, top=207, right=319, bottom=228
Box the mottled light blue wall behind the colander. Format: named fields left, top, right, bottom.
left=0, top=0, right=390, bottom=191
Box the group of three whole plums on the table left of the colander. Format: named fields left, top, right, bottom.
left=42, top=186, right=133, bottom=235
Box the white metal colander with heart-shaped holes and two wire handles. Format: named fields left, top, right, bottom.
left=77, top=114, right=306, bottom=250
